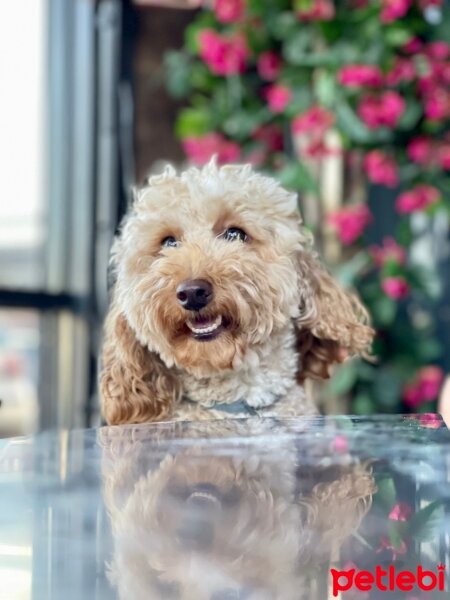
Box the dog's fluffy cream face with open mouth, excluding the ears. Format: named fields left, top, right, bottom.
left=115, top=165, right=306, bottom=373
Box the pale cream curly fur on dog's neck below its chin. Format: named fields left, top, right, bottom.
left=181, top=325, right=298, bottom=409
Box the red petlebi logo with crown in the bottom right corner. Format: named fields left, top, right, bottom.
left=330, top=565, right=445, bottom=597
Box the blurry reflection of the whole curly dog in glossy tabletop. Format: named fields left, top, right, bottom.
left=103, top=428, right=374, bottom=600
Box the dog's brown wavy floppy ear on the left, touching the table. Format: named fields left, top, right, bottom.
left=100, top=302, right=181, bottom=425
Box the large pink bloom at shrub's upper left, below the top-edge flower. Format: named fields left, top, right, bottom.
left=199, top=29, right=249, bottom=76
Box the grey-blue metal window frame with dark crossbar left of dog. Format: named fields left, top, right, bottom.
left=0, top=0, right=127, bottom=429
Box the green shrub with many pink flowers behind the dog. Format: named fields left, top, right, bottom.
left=167, top=0, right=450, bottom=413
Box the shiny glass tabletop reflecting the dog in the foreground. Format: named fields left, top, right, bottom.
left=0, top=415, right=450, bottom=600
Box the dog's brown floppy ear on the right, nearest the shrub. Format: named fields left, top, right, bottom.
left=295, top=252, right=375, bottom=382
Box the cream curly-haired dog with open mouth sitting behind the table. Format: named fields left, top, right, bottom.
left=100, top=161, right=373, bottom=424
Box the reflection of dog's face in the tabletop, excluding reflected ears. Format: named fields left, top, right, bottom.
left=108, top=448, right=302, bottom=600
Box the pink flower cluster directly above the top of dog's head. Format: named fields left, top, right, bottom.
left=182, top=132, right=241, bottom=165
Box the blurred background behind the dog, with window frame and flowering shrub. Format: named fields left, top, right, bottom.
left=0, top=0, right=450, bottom=436
